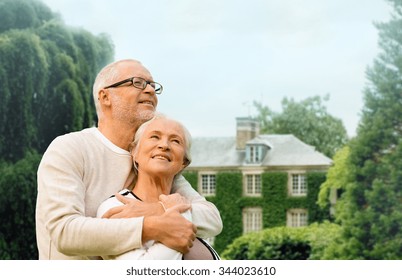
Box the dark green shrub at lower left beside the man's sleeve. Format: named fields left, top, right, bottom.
left=0, top=153, right=41, bottom=260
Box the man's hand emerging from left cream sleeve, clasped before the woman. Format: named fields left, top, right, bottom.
left=142, top=204, right=197, bottom=254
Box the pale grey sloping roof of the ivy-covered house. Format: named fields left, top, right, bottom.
left=189, top=134, right=332, bottom=168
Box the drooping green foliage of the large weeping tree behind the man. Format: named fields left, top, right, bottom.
left=0, top=0, right=113, bottom=162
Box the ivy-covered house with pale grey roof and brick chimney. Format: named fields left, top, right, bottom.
left=184, top=117, right=332, bottom=238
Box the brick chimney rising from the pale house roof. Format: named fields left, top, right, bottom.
left=236, top=117, right=260, bottom=150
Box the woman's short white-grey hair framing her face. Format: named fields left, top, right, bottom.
left=130, top=112, right=192, bottom=174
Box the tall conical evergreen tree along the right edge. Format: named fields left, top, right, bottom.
left=328, top=0, right=402, bottom=259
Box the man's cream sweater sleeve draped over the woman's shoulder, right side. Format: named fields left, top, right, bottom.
left=172, top=175, right=223, bottom=238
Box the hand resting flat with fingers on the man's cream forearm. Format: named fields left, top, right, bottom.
left=102, top=193, right=164, bottom=219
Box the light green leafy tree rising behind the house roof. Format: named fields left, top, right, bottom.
left=254, top=96, right=348, bottom=157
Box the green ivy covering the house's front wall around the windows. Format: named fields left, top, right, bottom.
left=183, top=171, right=329, bottom=253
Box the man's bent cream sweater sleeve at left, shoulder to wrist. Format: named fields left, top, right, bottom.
left=36, top=136, right=143, bottom=258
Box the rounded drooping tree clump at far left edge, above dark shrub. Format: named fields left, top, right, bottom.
left=0, top=30, right=48, bottom=161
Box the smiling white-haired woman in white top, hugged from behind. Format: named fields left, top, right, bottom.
left=97, top=115, right=219, bottom=260
